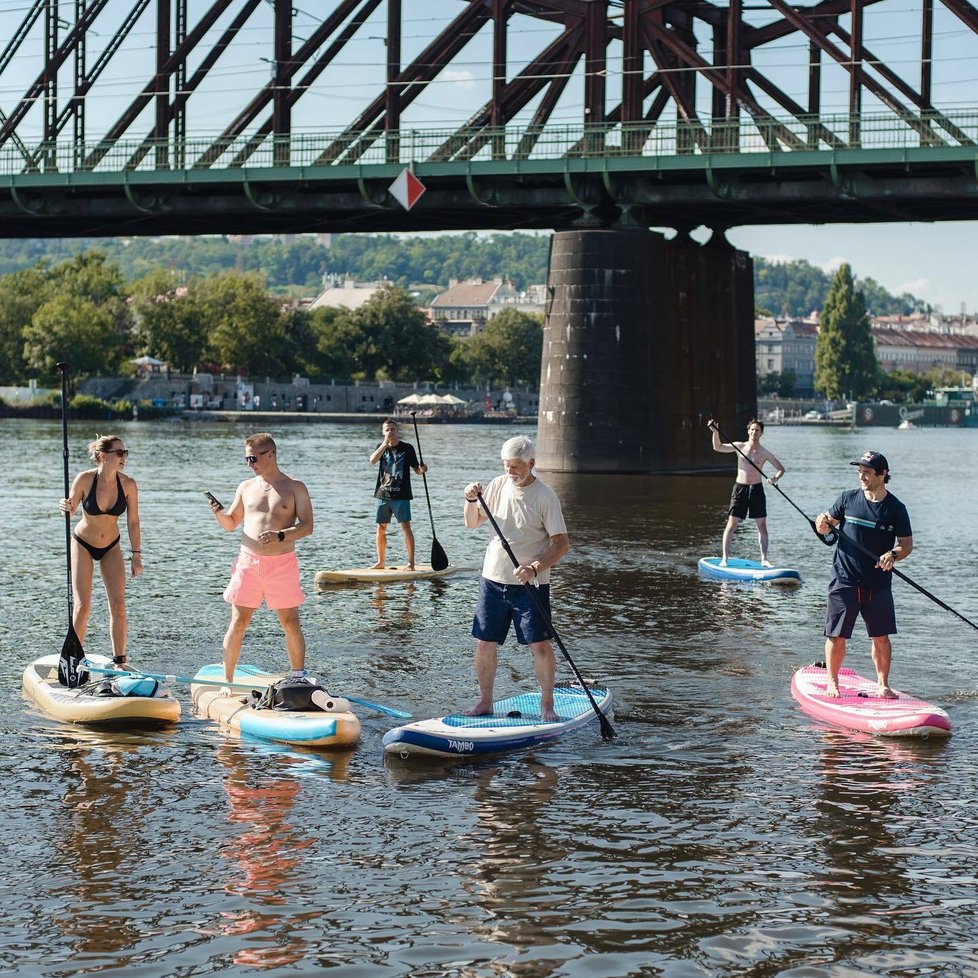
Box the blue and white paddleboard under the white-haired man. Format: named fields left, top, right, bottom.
left=384, top=686, right=612, bottom=758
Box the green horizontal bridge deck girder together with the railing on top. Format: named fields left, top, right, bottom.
left=0, top=111, right=978, bottom=238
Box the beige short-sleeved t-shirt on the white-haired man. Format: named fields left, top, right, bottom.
left=482, top=475, right=567, bottom=584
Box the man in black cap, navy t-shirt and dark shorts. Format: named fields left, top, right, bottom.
left=815, top=452, right=913, bottom=699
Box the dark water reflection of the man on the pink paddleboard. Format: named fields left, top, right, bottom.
left=815, top=732, right=946, bottom=917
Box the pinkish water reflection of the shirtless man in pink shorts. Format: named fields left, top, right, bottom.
left=217, top=742, right=351, bottom=968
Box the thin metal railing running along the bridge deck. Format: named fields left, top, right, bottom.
left=7, top=109, right=978, bottom=176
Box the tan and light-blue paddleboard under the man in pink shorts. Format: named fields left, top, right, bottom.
left=190, top=662, right=360, bottom=747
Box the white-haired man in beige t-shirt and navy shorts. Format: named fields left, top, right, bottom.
left=464, top=435, right=569, bottom=720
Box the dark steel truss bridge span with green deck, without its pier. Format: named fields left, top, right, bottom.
left=0, top=0, right=978, bottom=237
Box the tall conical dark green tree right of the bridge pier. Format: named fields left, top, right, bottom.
left=815, top=264, right=879, bottom=400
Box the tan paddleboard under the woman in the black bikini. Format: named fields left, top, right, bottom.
left=24, top=654, right=180, bottom=727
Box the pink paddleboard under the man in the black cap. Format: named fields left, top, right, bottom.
left=791, top=663, right=951, bottom=737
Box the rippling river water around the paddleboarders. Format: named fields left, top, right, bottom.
left=0, top=421, right=978, bottom=978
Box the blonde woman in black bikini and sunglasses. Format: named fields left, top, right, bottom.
left=58, top=435, right=143, bottom=669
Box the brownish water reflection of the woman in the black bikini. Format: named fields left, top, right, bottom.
left=57, top=733, right=141, bottom=954
